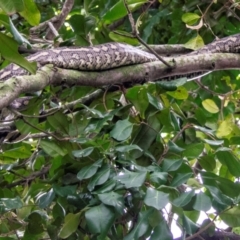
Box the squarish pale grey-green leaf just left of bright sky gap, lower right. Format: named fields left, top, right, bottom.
left=144, top=188, right=169, bottom=210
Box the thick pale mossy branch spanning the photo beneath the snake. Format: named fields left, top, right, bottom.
left=0, top=53, right=240, bottom=109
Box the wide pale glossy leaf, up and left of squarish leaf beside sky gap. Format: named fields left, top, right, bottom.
left=115, top=170, right=147, bottom=188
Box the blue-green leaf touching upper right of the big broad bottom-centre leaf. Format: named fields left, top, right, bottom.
left=98, top=192, right=124, bottom=214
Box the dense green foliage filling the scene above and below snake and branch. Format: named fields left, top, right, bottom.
left=0, top=0, right=240, bottom=240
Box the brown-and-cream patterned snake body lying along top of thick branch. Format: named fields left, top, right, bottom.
left=0, top=34, right=240, bottom=81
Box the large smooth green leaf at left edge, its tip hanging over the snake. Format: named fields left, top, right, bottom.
left=0, top=32, right=37, bottom=74
